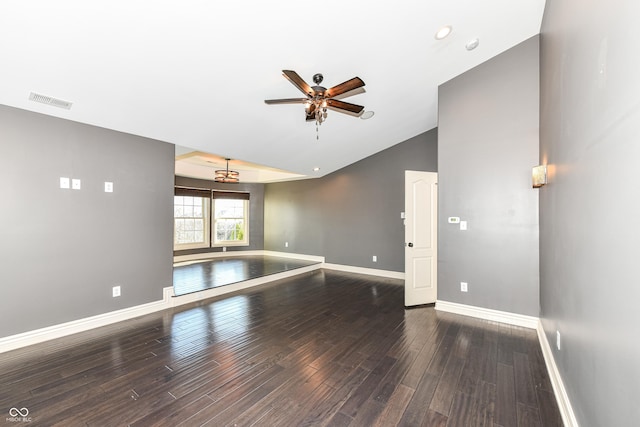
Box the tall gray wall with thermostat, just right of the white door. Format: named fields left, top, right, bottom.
left=438, top=37, right=539, bottom=317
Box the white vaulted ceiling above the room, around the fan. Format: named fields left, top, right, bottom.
left=0, top=0, right=545, bottom=181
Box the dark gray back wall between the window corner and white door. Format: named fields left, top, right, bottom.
left=265, top=129, right=437, bottom=271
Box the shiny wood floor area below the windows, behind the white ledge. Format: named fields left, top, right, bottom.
left=173, top=255, right=318, bottom=295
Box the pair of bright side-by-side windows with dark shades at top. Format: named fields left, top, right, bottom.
left=173, top=187, right=249, bottom=250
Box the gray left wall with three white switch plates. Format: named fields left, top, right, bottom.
left=0, top=106, right=174, bottom=337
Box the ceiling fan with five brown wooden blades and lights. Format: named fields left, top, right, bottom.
left=264, top=70, right=364, bottom=126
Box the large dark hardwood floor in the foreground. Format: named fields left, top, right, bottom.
left=0, top=270, right=562, bottom=427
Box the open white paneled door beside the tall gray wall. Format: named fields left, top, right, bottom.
left=404, top=171, right=438, bottom=307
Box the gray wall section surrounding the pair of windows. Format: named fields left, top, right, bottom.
left=174, top=176, right=264, bottom=255
